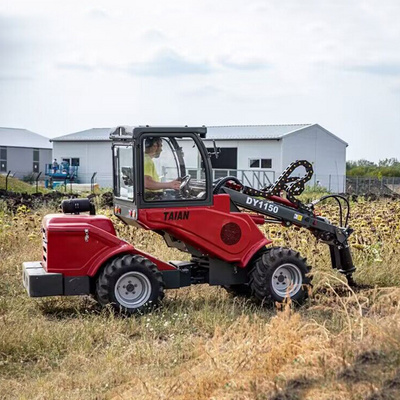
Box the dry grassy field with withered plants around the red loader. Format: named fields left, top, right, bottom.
left=0, top=201, right=400, bottom=400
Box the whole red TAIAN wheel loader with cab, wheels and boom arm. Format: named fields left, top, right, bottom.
left=23, top=126, right=355, bottom=315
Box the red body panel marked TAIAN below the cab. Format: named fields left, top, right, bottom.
left=138, top=194, right=271, bottom=267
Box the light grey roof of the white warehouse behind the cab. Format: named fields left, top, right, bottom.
left=52, top=124, right=347, bottom=145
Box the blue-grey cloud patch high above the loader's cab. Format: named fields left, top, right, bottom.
left=126, top=50, right=212, bottom=78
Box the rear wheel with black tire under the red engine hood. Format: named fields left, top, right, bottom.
left=96, top=254, right=165, bottom=315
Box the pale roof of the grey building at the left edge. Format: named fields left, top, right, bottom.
left=0, top=127, right=53, bottom=149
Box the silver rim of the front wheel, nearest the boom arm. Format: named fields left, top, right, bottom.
left=272, top=264, right=303, bottom=297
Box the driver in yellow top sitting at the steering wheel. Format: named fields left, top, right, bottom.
left=144, top=137, right=181, bottom=193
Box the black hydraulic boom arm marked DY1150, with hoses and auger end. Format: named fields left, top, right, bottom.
left=216, top=161, right=356, bottom=284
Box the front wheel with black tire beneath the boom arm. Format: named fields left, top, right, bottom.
left=250, top=247, right=312, bottom=304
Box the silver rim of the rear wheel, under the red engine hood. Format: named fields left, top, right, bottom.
left=114, top=271, right=151, bottom=308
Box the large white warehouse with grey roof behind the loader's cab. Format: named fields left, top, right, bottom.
left=52, top=124, right=348, bottom=192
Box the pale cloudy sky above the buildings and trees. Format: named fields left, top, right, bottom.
left=0, top=0, right=400, bottom=161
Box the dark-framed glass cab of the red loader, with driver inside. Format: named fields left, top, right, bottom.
left=110, top=127, right=212, bottom=224
